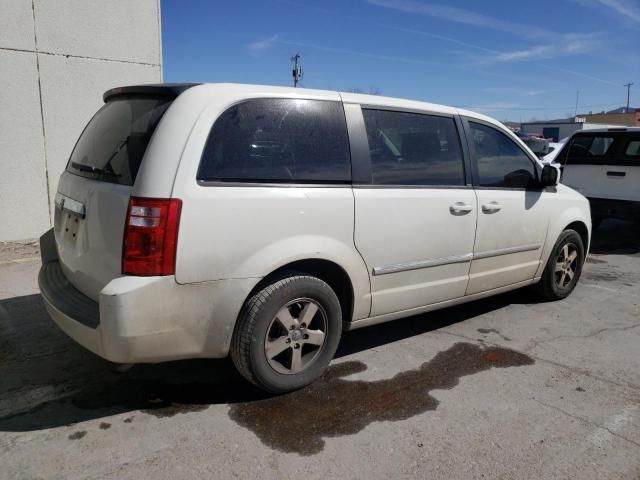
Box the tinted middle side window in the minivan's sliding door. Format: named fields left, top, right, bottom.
left=362, top=109, right=464, bottom=185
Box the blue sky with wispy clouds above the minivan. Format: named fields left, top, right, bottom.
left=161, top=0, right=640, bottom=121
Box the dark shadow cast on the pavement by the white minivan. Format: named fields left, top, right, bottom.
left=0, top=290, right=535, bottom=432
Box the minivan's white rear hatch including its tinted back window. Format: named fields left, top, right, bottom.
left=54, top=92, right=173, bottom=301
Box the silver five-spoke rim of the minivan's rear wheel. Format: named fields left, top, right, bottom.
left=264, top=298, right=328, bottom=375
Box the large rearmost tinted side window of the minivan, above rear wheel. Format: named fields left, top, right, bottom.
left=198, top=99, right=351, bottom=183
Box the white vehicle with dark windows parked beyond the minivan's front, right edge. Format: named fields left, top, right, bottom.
left=555, top=127, right=640, bottom=228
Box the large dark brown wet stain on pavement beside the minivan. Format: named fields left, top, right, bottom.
left=229, top=342, right=534, bottom=455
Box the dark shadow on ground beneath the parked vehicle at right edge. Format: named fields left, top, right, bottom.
left=590, top=219, right=640, bottom=255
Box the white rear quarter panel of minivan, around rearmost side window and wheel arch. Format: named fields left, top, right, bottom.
left=172, top=85, right=370, bottom=319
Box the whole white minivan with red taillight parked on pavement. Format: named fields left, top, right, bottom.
left=39, top=84, right=591, bottom=393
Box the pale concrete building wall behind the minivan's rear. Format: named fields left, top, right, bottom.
left=0, top=0, right=162, bottom=241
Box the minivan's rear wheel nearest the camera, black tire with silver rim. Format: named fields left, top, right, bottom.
left=231, top=272, right=342, bottom=394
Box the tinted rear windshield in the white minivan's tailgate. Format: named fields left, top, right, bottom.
left=67, top=97, right=171, bottom=185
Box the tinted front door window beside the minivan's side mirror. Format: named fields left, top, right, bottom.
left=469, top=122, right=536, bottom=188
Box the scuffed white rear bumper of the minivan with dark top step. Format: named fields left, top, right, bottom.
left=38, top=232, right=257, bottom=363
